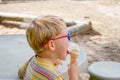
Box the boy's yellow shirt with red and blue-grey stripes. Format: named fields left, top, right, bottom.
left=24, top=57, right=64, bottom=80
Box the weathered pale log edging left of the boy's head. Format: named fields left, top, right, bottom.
left=0, top=12, right=37, bottom=29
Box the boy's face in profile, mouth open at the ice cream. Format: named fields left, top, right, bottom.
left=54, top=25, right=69, bottom=60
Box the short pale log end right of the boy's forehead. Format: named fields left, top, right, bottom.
left=68, top=21, right=92, bottom=36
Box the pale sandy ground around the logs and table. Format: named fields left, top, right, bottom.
left=0, top=0, right=120, bottom=80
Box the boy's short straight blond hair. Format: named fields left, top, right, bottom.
left=26, top=16, right=65, bottom=54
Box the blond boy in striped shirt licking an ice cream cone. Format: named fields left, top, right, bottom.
left=18, top=16, right=78, bottom=80
